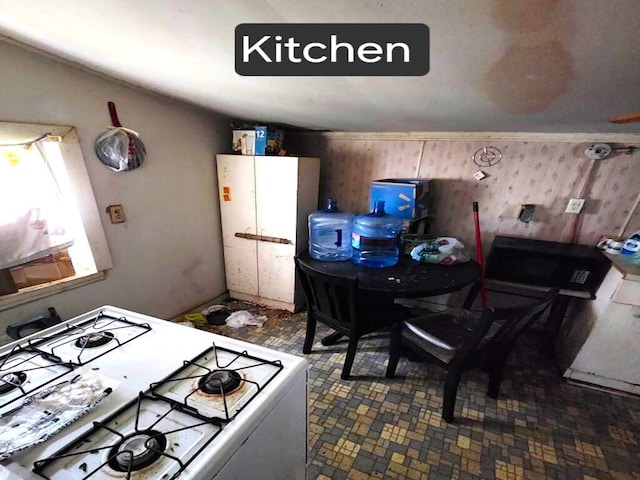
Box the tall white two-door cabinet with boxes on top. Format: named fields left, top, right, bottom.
left=216, top=155, right=320, bottom=311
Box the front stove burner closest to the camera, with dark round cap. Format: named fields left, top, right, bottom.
left=109, top=430, right=167, bottom=472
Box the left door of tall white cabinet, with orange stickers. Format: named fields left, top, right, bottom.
left=217, top=155, right=258, bottom=295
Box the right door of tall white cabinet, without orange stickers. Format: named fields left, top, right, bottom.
left=255, top=157, right=298, bottom=303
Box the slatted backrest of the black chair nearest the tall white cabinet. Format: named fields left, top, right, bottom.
left=295, top=258, right=358, bottom=332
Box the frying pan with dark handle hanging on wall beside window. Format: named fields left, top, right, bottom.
left=95, top=102, right=147, bottom=172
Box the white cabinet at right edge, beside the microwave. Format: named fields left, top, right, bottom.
left=557, top=256, right=640, bottom=394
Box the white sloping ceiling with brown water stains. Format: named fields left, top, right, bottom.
left=0, top=0, right=640, bottom=132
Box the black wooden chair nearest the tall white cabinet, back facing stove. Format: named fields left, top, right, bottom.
left=296, top=258, right=410, bottom=380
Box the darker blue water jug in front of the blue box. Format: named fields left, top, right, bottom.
left=351, top=200, right=402, bottom=268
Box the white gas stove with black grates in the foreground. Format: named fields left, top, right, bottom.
left=0, top=306, right=307, bottom=480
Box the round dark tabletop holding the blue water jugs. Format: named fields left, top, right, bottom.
left=298, top=250, right=480, bottom=298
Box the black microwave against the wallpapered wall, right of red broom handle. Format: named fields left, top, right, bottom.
left=485, top=235, right=611, bottom=297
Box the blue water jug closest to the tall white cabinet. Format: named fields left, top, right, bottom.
left=309, top=198, right=353, bottom=262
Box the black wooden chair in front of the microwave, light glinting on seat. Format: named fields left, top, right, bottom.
left=386, top=290, right=558, bottom=423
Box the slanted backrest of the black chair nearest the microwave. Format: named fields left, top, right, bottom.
left=478, top=289, right=558, bottom=356
